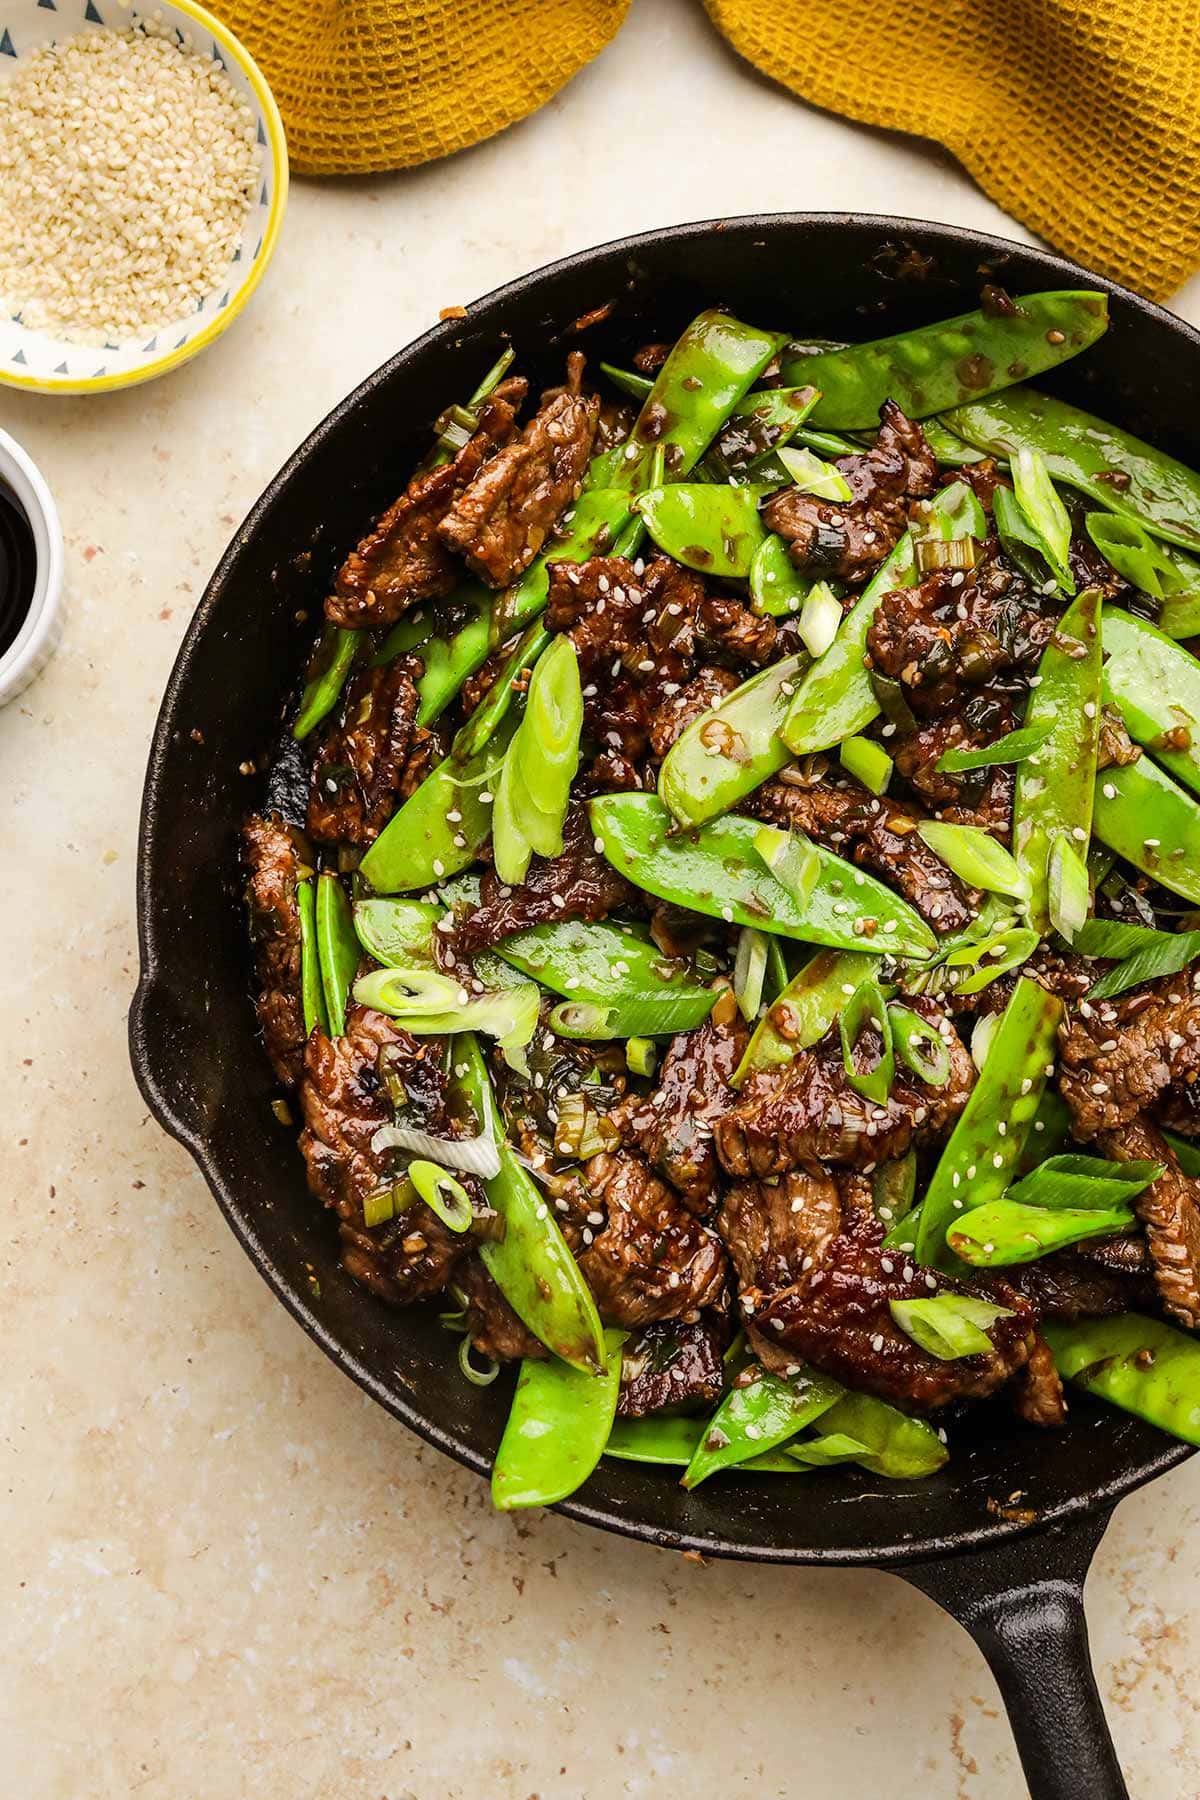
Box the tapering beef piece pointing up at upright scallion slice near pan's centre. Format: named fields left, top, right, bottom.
left=612, top=988, right=750, bottom=1213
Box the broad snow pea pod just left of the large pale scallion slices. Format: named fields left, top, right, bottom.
left=358, top=715, right=516, bottom=895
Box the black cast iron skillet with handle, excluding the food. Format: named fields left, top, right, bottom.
left=130, top=214, right=1200, bottom=1800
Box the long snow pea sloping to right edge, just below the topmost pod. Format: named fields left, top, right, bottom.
left=943, top=387, right=1200, bottom=551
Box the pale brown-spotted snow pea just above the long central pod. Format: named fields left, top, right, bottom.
left=658, top=653, right=808, bottom=824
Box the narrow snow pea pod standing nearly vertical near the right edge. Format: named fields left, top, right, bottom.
left=1013, top=587, right=1101, bottom=936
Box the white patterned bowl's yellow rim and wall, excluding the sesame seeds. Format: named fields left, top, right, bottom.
left=0, top=0, right=288, bottom=394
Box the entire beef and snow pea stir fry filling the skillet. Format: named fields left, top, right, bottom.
left=243, top=286, right=1200, bottom=1508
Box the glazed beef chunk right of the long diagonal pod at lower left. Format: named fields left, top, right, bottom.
left=579, top=1150, right=725, bottom=1328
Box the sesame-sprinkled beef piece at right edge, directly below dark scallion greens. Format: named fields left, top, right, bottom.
left=1058, top=972, right=1200, bottom=1141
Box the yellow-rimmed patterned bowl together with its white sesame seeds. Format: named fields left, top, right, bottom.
left=0, top=0, right=288, bottom=394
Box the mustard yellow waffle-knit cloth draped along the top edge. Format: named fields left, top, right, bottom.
left=221, top=0, right=1200, bottom=299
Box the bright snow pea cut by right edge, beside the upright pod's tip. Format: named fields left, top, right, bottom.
left=1103, top=607, right=1200, bottom=792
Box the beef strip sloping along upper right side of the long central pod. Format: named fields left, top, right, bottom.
left=747, top=778, right=975, bottom=932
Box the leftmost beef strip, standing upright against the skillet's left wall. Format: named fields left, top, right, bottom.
left=241, top=814, right=313, bottom=1087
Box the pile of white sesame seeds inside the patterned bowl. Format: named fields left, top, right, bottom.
left=0, top=29, right=259, bottom=344
